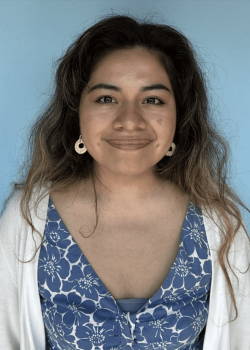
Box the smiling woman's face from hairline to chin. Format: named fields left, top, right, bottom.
left=79, top=48, right=176, bottom=175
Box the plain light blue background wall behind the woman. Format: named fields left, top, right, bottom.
left=0, top=0, right=250, bottom=221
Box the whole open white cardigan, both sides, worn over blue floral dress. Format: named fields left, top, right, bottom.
left=0, top=186, right=250, bottom=350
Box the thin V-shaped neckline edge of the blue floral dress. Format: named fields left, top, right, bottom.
left=49, top=197, right=193, bottom=313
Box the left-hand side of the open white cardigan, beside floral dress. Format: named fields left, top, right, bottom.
left=0, top=189, right=49, bottom=350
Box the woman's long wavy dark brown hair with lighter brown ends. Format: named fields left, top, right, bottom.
left=2, top=14, right=250, bottom=322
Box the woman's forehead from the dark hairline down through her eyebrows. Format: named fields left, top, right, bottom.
left=81, top=47, right=174, bottom=100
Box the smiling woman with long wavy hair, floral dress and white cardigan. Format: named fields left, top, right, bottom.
left=0, top=15, right=250, bottom=350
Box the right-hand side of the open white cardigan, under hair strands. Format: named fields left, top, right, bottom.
left=203, top=205, right=250, bottom=350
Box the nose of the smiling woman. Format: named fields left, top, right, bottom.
left=113, top=102, right=147, bottom=131
